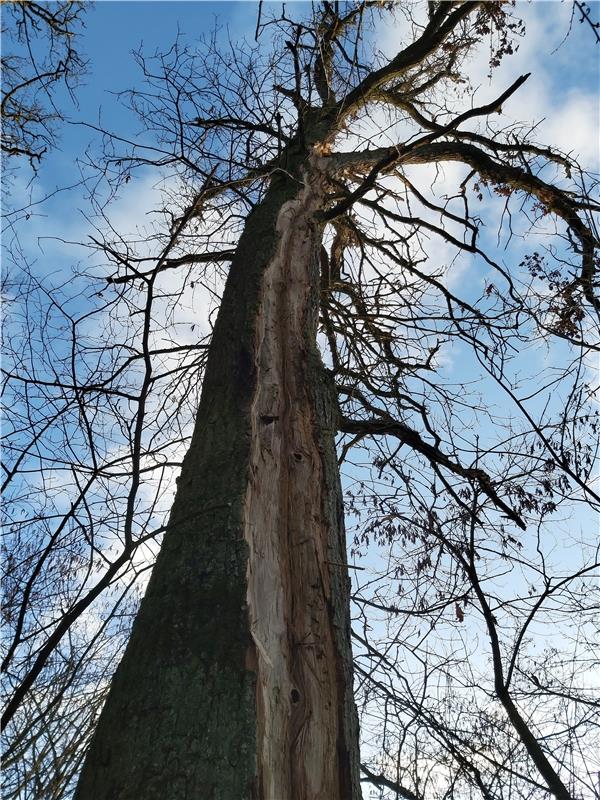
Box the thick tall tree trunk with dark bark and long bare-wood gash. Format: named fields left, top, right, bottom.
left=76, top=152, right=360, bottom=800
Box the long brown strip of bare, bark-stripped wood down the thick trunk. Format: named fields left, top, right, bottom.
left=244, top=164, right=354, bottom=800
